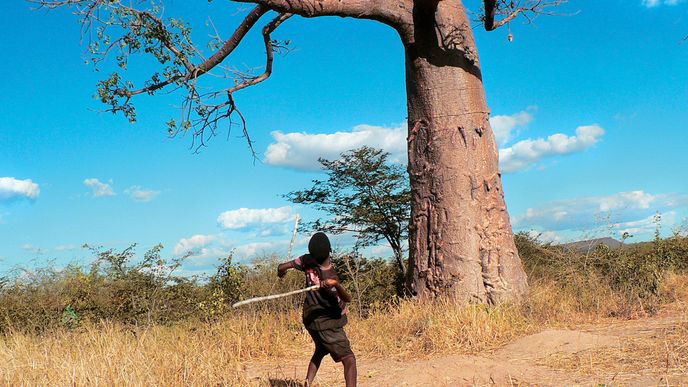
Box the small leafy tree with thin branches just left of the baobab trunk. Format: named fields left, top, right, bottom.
left=285, top=146, right=411, bottom=276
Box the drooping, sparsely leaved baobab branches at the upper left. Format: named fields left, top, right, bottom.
left=30, top=0, right=300, bottom=157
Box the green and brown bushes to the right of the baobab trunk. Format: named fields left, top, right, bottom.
left=516, top=233, right=688, bottom=316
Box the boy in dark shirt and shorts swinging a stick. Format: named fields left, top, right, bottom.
left=277, top=232, right=357, bottom=387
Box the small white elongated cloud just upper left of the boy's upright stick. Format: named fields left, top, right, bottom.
left=217, top=206, right=295, bottom=230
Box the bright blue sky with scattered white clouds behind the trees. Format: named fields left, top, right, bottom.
left=0, top=0, right=688, bottom=273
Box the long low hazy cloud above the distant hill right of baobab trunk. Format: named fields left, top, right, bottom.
left=513, top=191, right=688, bottom=231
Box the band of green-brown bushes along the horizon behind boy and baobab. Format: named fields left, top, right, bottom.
left=0, top=234, right=688, bottom=333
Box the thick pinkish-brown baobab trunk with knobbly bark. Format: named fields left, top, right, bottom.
left=401, top=0, right=527, bottom=304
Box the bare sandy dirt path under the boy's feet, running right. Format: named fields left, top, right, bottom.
left=246, top=316, right=688, bottom=386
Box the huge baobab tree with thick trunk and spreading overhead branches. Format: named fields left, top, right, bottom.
left=33, top=0, right=565, bottom=303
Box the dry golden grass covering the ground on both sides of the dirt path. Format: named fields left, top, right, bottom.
left=0, top=276, right=688, bottom=385
